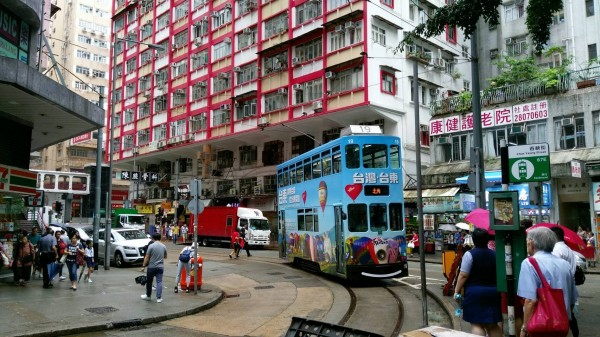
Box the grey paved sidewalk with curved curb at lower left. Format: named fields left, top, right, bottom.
left=0, top=267, right=223, bottom=336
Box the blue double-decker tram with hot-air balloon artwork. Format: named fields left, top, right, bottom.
left=277, top=125, right=408, bottom=279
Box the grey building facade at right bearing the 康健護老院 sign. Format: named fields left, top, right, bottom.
left=424, top=0, right=600, bottom=241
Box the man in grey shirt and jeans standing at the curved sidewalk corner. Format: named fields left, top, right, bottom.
left=140, top=233, right=167, bottom=303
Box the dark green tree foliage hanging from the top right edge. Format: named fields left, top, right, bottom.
left=399, top=0, right=563, bottom=53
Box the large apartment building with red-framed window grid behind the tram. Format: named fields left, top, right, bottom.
left=107, top=0, right=469, bottom=222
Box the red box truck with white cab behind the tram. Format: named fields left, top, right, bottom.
left=196, top=206, right=271, bottom=246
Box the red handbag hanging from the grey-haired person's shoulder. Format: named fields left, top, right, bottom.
left=527, top=257, right=569, bottom=337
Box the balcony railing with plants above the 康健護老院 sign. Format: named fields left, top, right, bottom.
left=430, top=67, right=600, bottom=116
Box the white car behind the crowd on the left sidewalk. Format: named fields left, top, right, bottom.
left=98, top=228, right=150, bottom=268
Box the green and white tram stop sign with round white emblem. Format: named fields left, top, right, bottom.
left=508, top=143, right=550, bottom=183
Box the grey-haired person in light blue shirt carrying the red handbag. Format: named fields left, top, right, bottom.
left=517, top=227, right=578, bottom=337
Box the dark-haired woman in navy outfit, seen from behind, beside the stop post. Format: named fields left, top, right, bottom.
left=454, top=228, right=503, bottom=337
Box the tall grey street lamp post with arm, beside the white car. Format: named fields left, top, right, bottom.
left=104, top=36, right=165, bottom=270
